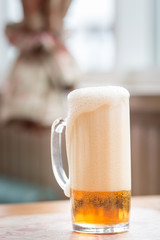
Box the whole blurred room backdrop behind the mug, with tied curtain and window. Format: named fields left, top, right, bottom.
left=0, top=0, right=160, bottom=203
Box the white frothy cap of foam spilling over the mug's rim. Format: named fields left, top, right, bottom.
left=68, top=86, right=130, bottom=124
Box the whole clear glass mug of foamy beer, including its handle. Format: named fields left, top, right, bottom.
left=51, top=86, right=131, bottom=233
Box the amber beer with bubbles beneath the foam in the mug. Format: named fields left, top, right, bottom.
left=71, top=189, right=131, bottom=225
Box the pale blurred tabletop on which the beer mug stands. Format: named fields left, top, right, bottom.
left=0, top=196, right=160, bottom=240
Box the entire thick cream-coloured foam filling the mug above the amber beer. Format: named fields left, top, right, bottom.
left=66, top=86, right=131, bottom=191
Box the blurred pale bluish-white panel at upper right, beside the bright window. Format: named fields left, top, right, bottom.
left=116, top=0, right=156, bottom=70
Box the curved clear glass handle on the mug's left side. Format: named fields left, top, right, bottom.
left=51, top=118, right=70, bottom=197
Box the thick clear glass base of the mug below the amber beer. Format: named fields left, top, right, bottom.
left=73, top=223, right=129, bottom=234
